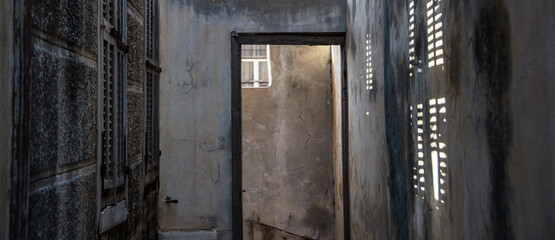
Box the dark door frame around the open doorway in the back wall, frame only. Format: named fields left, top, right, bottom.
left=231, top=32, right=350, bottom=240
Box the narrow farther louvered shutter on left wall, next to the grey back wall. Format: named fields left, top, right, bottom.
left=144, top=0, right=161, bottom=187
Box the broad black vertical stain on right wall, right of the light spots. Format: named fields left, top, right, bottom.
left=474, top=0, right=513, bottom=239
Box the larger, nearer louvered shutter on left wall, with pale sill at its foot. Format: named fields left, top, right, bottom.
left=99, top=0, right=128, bottom=233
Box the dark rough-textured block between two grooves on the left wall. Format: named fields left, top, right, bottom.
left=30, top=46, right=97, bottom=172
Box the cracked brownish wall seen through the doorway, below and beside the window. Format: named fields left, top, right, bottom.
left=242, top=45, right=334, bottom=240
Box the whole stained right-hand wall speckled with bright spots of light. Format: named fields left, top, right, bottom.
left=347, top=0, right=555, bottom=239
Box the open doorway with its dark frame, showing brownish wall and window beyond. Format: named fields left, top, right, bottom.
left=232, top=33, right=349, bottom=239
